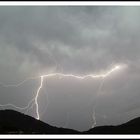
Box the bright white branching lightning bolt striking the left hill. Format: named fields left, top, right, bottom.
left=0, top=65, right=121, bottom=124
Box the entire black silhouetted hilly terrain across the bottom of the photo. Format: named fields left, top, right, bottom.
left=0, top=110, right=140, bottom=134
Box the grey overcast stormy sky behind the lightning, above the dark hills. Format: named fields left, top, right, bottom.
left=0, top=6, right=140, bottom=131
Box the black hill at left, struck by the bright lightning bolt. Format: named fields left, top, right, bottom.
left=0, top=110, right=78, bottom=134
